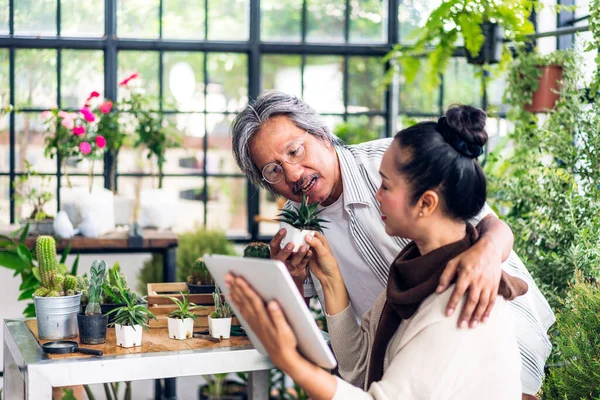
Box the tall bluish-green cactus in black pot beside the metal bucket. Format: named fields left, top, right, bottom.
left=77, top=260, right=108, bottom=344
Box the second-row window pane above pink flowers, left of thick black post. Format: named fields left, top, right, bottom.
left=60, top=50, right=104, bottom=109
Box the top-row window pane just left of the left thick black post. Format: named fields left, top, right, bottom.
left=60, top=0, right=104, bottom=37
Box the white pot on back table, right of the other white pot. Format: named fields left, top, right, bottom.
left=138, top=189, right=177, bottom=229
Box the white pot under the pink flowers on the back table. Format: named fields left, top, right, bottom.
left=60, top=186, right=115, bottom=237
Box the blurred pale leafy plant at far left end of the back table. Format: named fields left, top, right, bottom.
left=14, top=160, right=53, bottom=234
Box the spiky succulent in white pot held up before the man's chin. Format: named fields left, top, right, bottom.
left=277, top=195, right=328, bottom=251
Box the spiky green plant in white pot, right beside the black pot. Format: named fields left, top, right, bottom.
left=108, top=281, right=158, bottom=347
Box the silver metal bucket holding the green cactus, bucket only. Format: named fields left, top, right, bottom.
left=33, top=293, right=81, bottom=340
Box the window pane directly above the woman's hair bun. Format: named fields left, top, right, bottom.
left=444, top=57, right=482, bottom=107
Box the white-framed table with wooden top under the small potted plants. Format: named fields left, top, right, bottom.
left=3, top=319, right=272, bottom=400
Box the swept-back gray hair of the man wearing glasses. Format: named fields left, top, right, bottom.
left=231, top=90, right=344, bottom=194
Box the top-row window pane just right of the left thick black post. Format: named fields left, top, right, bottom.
left=116, top=0, right=158, bottom=39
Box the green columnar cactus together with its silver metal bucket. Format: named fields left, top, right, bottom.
left=33, top=236, right=81, bottom=340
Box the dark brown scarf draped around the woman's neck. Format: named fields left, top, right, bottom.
left=367, top=224, right=527, bottom=388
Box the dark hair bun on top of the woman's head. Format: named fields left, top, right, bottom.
left=446, top=105, right=488, bottom=146
